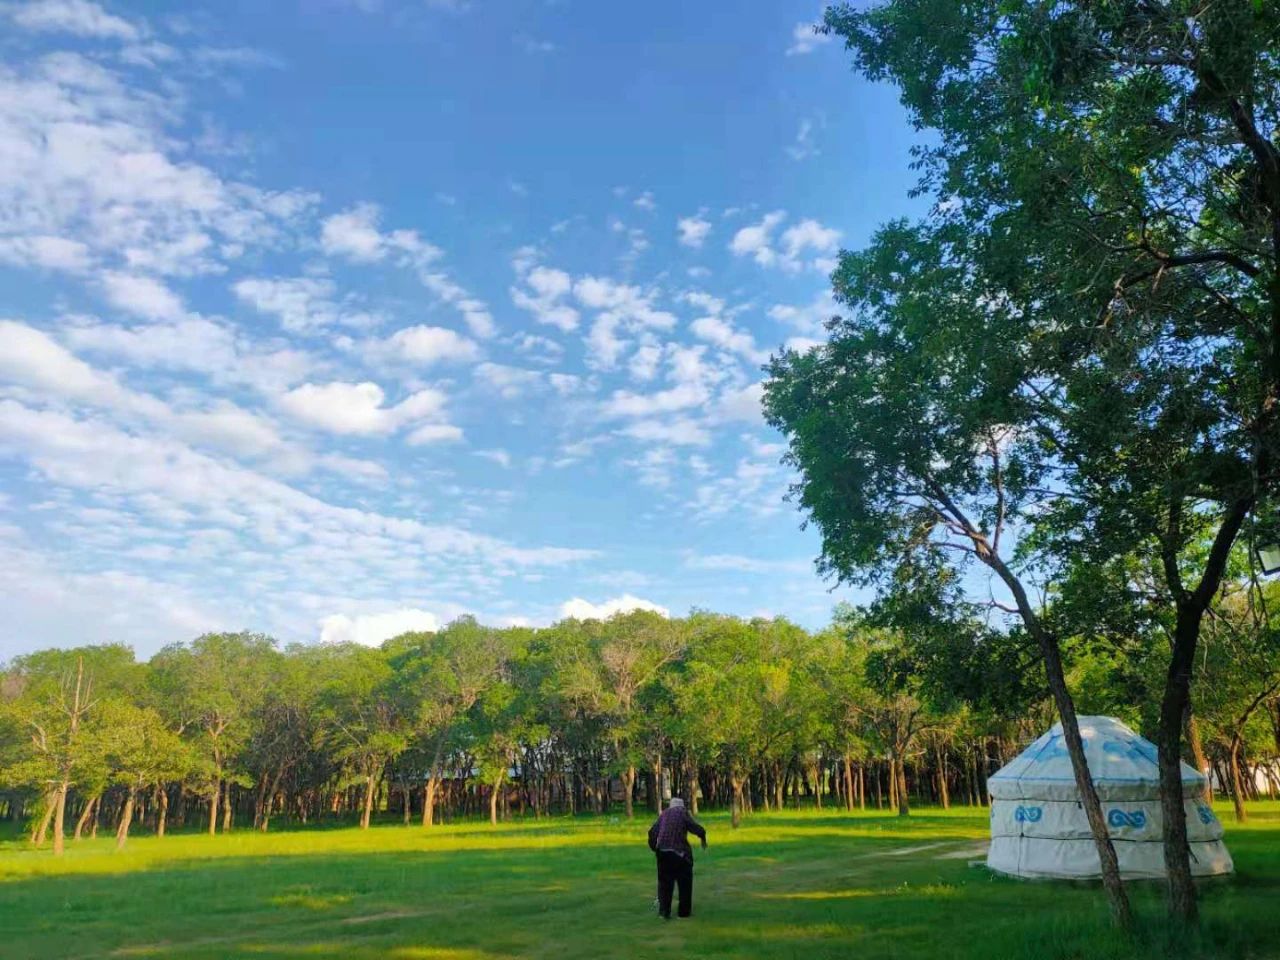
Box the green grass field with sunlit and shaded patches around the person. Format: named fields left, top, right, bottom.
left=0, top=804, right=1280, bottom=960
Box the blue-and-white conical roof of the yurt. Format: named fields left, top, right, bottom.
left=987, top=717, right=1204, bottom=800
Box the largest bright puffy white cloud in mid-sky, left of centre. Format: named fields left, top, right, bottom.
left=280, top=381, right=447, bottom=434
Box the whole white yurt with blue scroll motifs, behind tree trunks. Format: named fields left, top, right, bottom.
left=987, top=717, right=1231, bottom=879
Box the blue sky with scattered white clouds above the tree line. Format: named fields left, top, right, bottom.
left=0, top=0, right=919, bottom=657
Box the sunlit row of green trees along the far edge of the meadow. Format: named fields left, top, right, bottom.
left=0, top=589, right=1280, bottom=852
